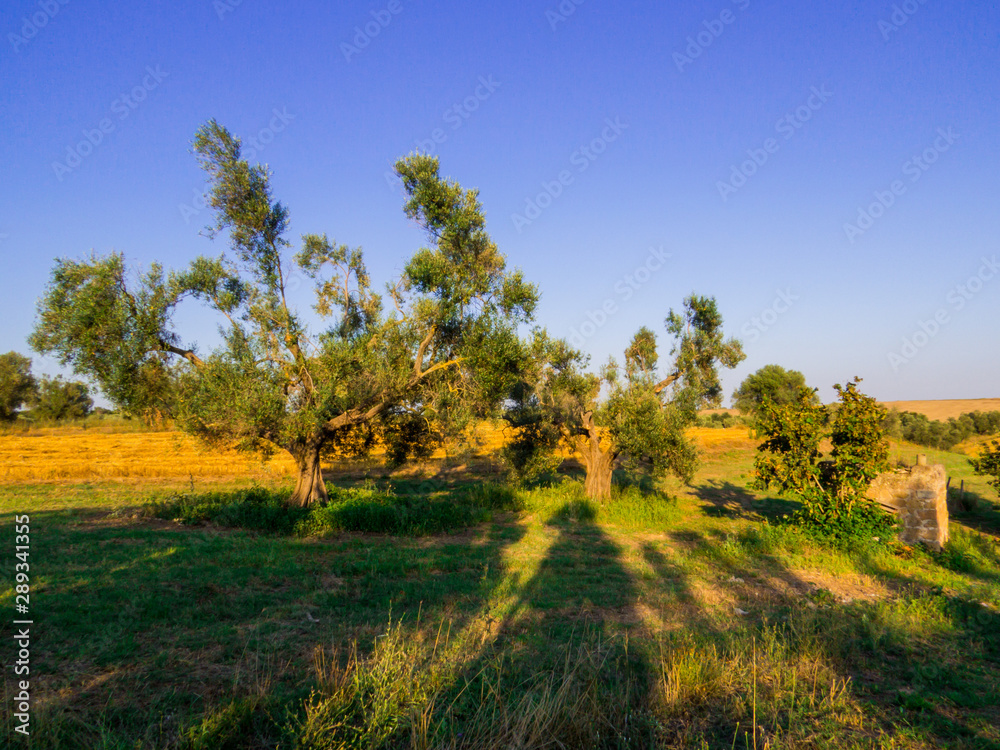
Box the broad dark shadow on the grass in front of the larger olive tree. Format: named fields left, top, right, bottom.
left=0, top=490, right=524, bottom=747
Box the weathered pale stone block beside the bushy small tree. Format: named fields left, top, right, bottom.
left=868, top=462, right=948, bottom=550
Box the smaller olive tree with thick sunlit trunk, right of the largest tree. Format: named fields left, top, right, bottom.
left=505, top=295, right=744, bottom=500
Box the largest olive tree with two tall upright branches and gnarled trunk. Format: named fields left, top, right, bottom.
left=31, top=120, right=537, bottom=505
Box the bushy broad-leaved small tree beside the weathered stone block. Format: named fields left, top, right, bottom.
left=753, top=378, right=889, bottom=535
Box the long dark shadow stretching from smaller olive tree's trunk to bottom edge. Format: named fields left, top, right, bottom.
left=449, top=502, right=655, bottom=748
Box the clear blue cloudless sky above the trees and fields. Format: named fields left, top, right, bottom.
left=0, top=0, right=1000, bottom=400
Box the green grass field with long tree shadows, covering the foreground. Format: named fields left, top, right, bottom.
left=0, top=439, right=1000, bottom=749
